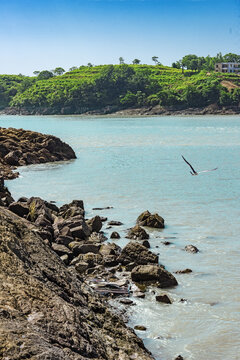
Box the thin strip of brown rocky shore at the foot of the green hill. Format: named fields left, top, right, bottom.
left=0, top=104, right=240, bottom=117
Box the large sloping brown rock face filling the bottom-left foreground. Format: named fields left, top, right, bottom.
left=0, top=207, right=153, bottom=360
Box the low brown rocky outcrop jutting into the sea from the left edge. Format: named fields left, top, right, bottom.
left=0, top=128, right=76, bottom=179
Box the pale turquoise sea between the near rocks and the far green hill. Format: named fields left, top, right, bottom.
left=0, top=116, right=240, bottom=360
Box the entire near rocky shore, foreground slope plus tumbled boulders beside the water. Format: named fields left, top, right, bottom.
left=0, top=129, right=184, bottom=360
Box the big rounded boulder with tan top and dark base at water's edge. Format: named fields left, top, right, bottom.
left=131, top=265, right=178, bottom=288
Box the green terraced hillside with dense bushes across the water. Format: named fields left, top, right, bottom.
left=0, top=64, right=240, bottom=114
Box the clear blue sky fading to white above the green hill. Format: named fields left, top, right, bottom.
left=0, top=0, right=240, bottom=75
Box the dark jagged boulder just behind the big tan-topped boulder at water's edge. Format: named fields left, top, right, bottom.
left=118, top=242, right=158, bottom=265
